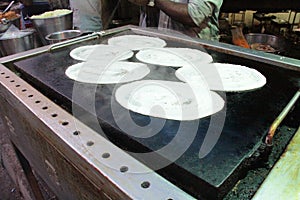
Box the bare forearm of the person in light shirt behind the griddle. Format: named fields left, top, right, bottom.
left=155, top=0, right=196, bottom=26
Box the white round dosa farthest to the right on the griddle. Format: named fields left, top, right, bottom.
left=175, top=63, right=267, bottom=92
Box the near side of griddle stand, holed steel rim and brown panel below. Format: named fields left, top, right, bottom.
left=0, top=58, right=194, bottom=199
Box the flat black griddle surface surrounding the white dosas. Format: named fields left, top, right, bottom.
left=14, top=31, right=299, bottom=200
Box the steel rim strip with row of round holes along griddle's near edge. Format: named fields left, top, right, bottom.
left=0, top=64, right=194, bottom=199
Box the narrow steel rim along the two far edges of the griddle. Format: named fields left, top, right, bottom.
left=0, top=25, right=300, bottom=72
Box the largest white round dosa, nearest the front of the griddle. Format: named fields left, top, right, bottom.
left=115, top=80, right=224, bottom=121
